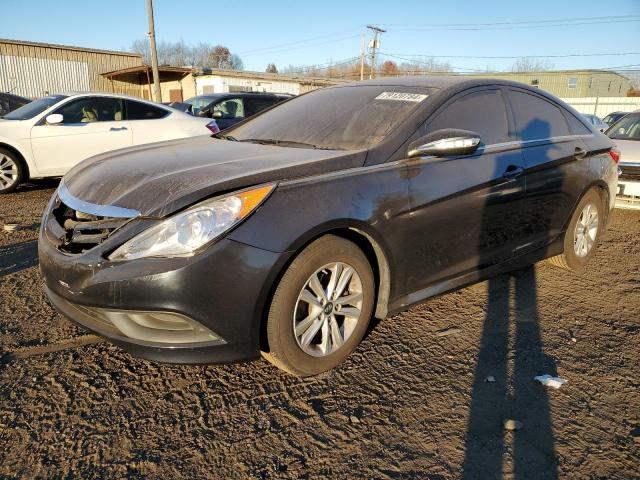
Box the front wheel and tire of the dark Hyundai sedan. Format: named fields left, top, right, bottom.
left=263, top=235, right=375, bottom=377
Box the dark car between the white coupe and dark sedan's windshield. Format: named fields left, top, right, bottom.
left=171, top=93, right=291, bottom=130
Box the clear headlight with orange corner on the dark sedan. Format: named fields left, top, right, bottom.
left=109, top=184, right=275, bottom=260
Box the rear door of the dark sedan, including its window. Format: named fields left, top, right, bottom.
left=508, top=88, right=592, bottom=250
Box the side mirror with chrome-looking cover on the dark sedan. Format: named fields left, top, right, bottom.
left=407, top=128, right=480, bottom=158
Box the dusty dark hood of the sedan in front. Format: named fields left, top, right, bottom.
left=63, top=136, right=366, bottom=217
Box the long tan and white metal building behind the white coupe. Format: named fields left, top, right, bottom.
left=0, top=39, right=142, bottom=98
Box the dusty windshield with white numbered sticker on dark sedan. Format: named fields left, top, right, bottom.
left=225, top=86, right=435, bottom=150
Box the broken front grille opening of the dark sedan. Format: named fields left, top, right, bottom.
left=50, top=200, right=129, bottom=254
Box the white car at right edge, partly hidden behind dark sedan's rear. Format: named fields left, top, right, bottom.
left=606, top=110, right=640, bottom=206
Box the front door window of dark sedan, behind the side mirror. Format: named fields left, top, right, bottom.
left=425, top=90, right=509, bottom=145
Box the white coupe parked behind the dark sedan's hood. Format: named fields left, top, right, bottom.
left=0, top=93, right=219, bottom=193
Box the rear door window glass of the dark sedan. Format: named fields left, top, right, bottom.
left=509, top=90, right=569, bottom=141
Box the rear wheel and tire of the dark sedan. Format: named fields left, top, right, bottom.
left=549, top=189, right=605, bottom=272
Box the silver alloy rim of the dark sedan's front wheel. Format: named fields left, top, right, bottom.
left=293, top=262, right=363, bottom=357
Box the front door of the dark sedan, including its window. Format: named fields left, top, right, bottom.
left=407, top=88, right=525, bottom=291
